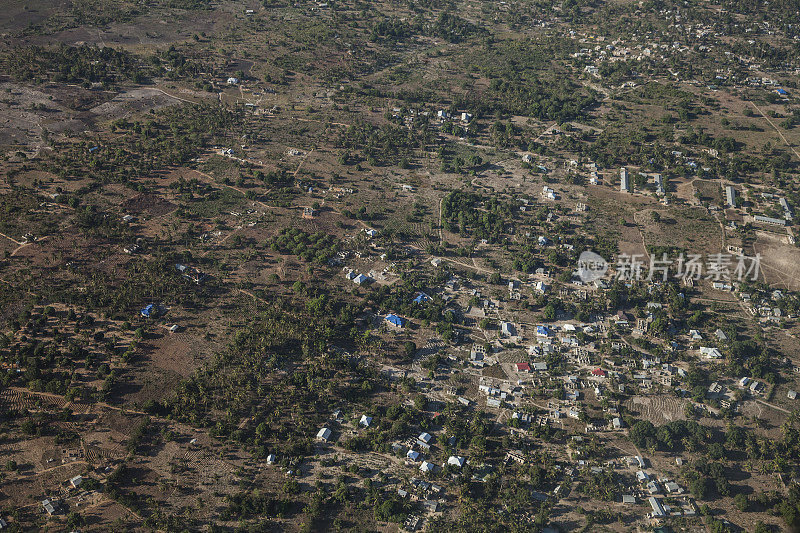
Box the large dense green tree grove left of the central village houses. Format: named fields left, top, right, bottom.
left=165, top=301, right=382, bottom=458
